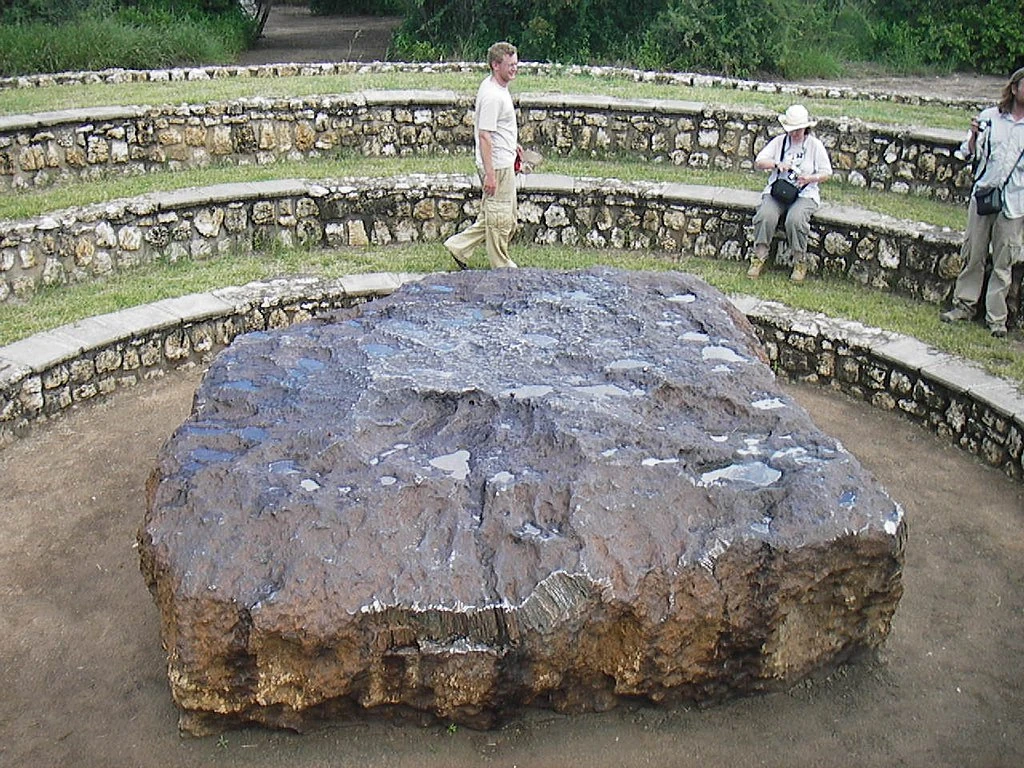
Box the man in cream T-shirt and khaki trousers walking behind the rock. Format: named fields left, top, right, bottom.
left=444, top=42, right=521, bottom=269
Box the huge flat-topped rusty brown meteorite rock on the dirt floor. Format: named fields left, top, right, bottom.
left=140, top=269, right=904, bottom=732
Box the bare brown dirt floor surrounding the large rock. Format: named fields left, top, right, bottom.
left=0, top=9, right=1024, bottom=768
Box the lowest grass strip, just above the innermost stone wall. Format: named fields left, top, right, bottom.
left=0, top=244, right=1024, bottom=384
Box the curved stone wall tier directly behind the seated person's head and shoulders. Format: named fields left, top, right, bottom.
left=0, top=91, right=971, bottom=203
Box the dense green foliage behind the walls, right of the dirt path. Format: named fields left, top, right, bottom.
left=385, top=0, right=1024, bottom=78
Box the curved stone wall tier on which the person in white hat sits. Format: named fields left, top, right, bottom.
left=0, top=174, right=963, bottom=309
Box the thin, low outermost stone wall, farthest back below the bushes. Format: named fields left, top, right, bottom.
left=0, top=61, right=987, bottom=111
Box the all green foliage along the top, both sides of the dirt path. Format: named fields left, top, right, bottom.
left=0, top=0, right=1024, bottom=79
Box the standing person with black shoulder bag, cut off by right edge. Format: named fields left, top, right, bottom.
left=939, top=67, right=1024, bottom=338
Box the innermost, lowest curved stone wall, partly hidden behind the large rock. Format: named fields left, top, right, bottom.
left=0, top=274, right=1024, bottom=481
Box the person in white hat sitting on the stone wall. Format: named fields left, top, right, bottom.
left=746, top=104, right=833, bottom=283
